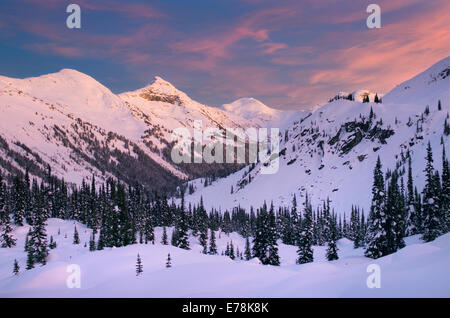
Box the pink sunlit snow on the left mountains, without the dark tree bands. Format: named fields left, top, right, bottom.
left=0, top=69, right=282, bottom=184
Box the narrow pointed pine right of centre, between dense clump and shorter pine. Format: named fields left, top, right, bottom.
left=297, top=194, right=314, bottom=264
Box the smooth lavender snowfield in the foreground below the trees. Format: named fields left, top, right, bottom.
left=0, top=219, right=450, bottom=298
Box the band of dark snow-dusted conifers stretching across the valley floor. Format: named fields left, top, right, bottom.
left=0, top=144, right=450, bottom=268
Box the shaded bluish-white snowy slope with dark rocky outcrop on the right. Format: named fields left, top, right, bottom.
left=186, top=57, right=450, bottom=214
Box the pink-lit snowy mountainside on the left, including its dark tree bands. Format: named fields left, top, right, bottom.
left=0, top=69, right=274, bottom=188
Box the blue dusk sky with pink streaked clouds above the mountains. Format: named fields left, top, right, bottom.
left=0, top=0, right=450, bottom=109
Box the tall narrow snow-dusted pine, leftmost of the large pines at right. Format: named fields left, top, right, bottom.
left=365, top=157, right=388, bottom=259
